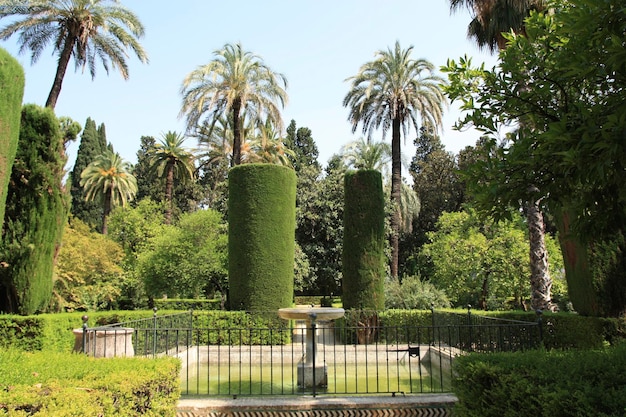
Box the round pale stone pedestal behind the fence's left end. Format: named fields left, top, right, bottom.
left=74, top=327, right=135, bottom=358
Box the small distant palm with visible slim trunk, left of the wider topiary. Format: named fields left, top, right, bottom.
left=149, top=131, right=195, bottom=224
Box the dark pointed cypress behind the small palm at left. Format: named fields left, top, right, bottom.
left=70, top=117, right=107, bottom=230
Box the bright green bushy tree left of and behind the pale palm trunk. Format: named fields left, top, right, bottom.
left=423, top=210, right=562, bottom=309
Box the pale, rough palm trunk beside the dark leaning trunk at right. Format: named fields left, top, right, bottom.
left=526, top=201, right=556, bottom=311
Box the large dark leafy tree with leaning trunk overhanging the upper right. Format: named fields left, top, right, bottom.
left=450, top=1, right=626, bottom=315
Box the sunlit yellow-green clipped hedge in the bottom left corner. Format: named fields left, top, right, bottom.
left=0, top=350, right=180, bottom=417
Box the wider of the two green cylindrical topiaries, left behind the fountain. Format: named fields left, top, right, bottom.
left=228, top=164, right=296, bottom=312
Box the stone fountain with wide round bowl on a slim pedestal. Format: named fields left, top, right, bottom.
left=278, top=307, right=345, bottom=388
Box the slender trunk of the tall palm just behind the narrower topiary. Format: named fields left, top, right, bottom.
left=390, top=118, right=402, bottom=278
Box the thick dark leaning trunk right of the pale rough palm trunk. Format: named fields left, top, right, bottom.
left=554, top=207, right=600, bottom=316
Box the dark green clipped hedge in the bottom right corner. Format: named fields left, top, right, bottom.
left=453, top=344, right=626, bottom=417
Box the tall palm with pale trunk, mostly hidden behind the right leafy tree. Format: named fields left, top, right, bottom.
left=450, top=0, right=555, bottom=310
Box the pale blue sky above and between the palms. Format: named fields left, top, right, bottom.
left=0, top=0, right=495, bottom=169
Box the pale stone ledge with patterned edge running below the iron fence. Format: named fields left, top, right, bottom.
left=176, top=394, right=457, bottom=417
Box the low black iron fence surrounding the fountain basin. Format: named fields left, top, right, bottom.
left=75, top=309, right=541, bottom=397
